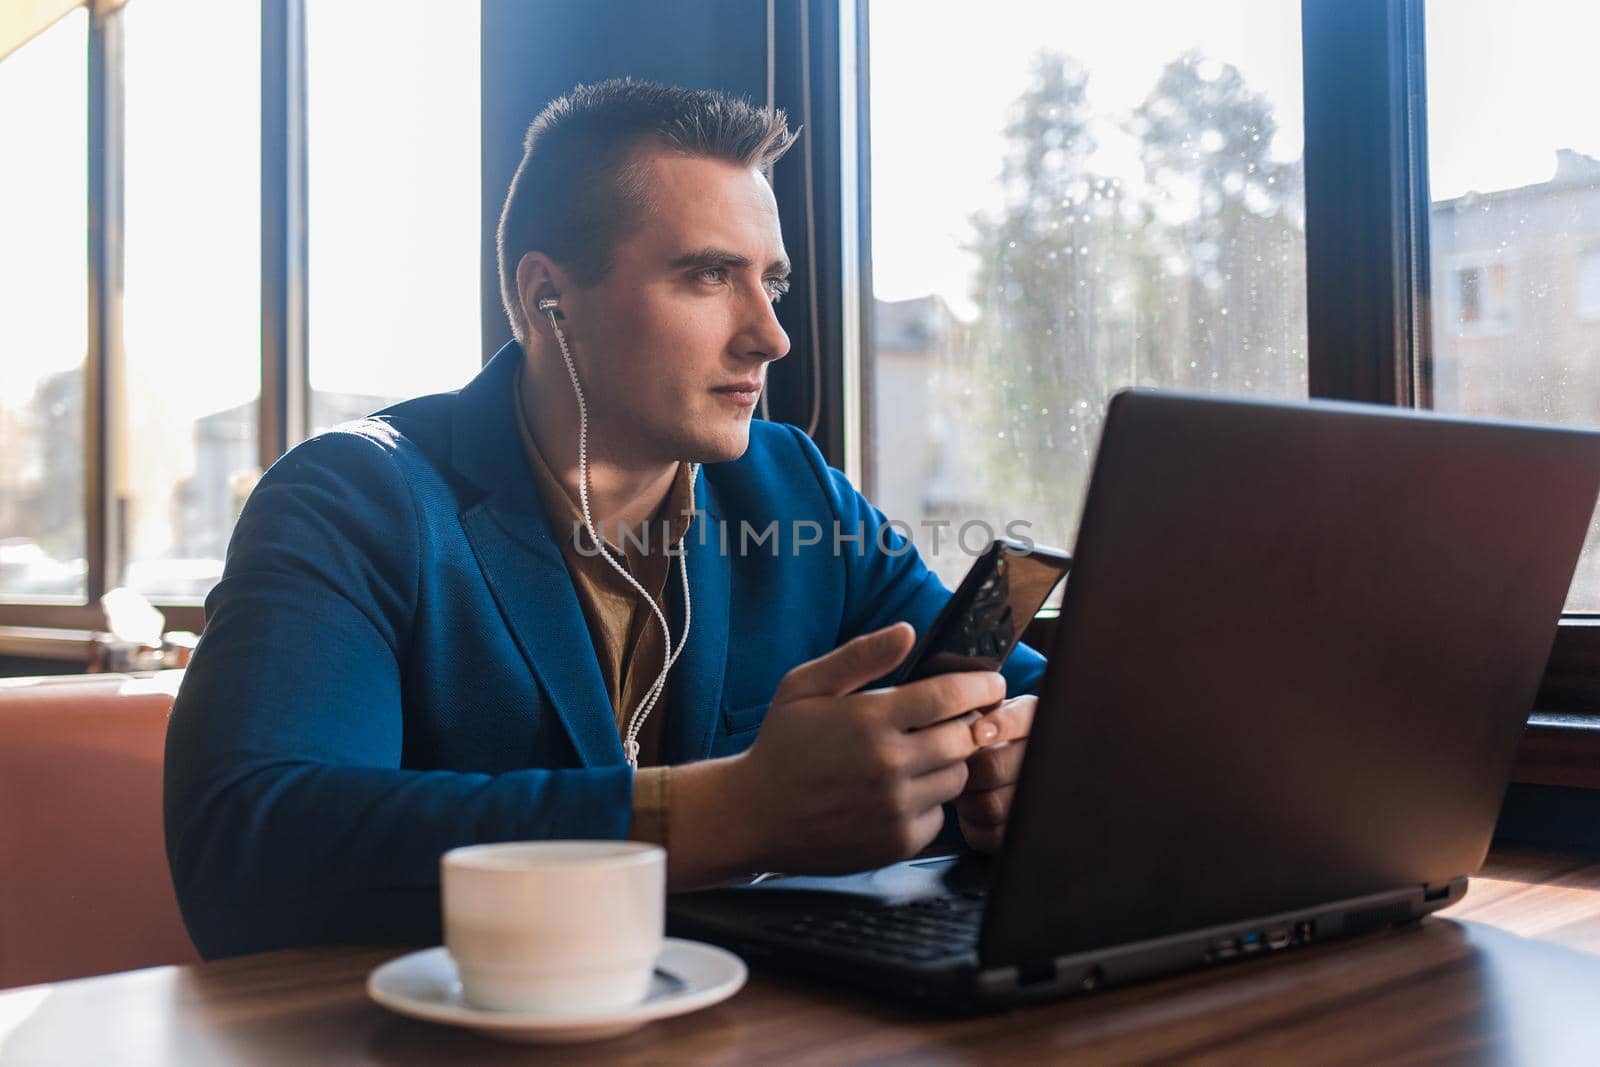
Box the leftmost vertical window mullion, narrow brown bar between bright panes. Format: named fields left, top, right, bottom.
left=83, top=6, right=126, bottom=608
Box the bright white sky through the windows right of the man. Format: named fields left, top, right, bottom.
left=870, top=0, right=1600, bottom=315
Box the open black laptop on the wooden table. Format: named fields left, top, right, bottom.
left=667, top=390, right=1600, bottom=1009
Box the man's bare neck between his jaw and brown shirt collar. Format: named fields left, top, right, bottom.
left=517, top=355, right=678, bottom=542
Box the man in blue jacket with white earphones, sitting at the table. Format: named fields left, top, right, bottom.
left=165, top=82, right=1043, bottom=957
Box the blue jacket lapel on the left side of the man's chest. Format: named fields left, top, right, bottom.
left=451, top=342, right=624, bottom=766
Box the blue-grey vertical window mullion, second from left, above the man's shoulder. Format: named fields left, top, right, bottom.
left=259, top=0, right=310, bottom=469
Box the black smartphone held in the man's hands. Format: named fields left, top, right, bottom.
left=885, top=537, right=1072, bottom=685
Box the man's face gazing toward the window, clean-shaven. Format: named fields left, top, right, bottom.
left=562, top=152, right=789, bottom=466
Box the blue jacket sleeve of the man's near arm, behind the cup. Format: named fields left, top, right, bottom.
left=163, top=422, right=632, bottom=958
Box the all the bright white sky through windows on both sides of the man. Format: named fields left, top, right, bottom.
left=0, top=0, right=1600, bottom=414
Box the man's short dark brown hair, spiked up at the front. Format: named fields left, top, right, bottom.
left=494, top=78, right=798, bottom=342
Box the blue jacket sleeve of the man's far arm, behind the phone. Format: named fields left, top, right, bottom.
left=789, top=427, right=1045, bottom=696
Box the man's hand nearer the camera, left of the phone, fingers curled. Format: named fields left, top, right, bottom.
left=710, top=622, right=1005, bottom=873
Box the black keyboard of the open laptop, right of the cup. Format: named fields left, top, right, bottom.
left=766, top=893, right=984, bottom=963
